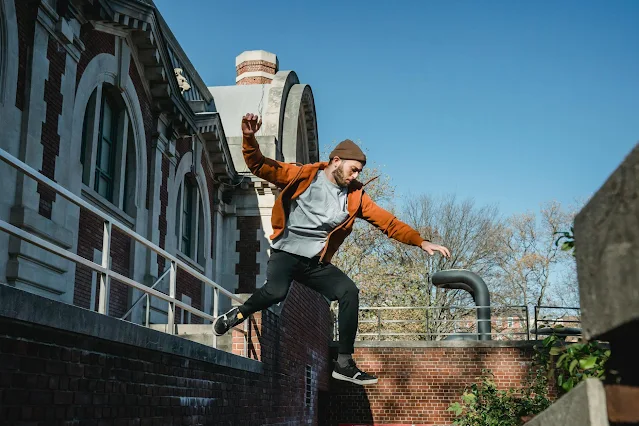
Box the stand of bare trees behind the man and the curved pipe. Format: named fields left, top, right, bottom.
left=324, top=145, right=578, bottom=338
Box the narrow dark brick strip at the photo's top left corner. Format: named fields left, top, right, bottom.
left=15, top=0, right=38, bottom=111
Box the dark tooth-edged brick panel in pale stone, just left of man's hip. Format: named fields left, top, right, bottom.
left=235, top=216, right=261, bottom=293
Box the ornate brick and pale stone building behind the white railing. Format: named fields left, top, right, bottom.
left=0, top=0, right=319, bottom=323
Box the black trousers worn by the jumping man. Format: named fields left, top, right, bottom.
left=239, top=249, right=359, bottom=354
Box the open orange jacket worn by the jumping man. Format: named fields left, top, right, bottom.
left=242, top=135, right=426, bottom=263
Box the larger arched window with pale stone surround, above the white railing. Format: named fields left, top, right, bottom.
left=80, top=84, right=136, bottom=217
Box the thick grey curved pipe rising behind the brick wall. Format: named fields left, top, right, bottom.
left=432, top=269, right=492, bottom=340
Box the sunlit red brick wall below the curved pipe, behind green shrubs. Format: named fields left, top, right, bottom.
left=320, top=347, right=552, bottom=426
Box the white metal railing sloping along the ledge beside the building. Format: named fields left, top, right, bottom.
left=0, top=148, right=249, bottom=356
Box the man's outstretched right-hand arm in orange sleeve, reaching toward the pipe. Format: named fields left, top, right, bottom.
left=360, top=192, right=450, bottom=257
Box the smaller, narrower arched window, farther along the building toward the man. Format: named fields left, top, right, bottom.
left=175, top=173, right=205, bottom=266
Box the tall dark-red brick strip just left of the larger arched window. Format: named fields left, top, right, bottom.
left=38, top=38, right=67, bottom=219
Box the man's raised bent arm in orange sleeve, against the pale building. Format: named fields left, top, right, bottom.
left=242, top=114, right=300, bottom=188
